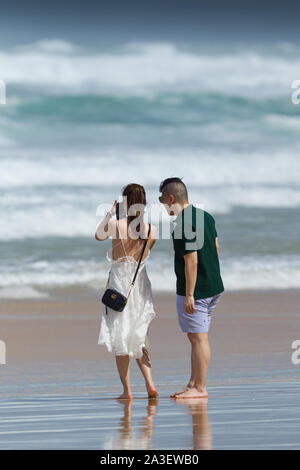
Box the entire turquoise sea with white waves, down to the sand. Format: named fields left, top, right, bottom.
left=0, top=40, right=300, bottom=298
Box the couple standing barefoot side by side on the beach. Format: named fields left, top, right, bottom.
left=95, top=177, right=224, bottom=399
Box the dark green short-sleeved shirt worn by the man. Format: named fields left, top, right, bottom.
left=172, top=204, right=224, bottom=300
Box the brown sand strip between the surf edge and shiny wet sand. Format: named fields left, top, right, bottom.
left=0, top=290, right=300, bottom=365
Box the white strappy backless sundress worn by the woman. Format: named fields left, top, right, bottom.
left=98, top=231, right=156, bottom=359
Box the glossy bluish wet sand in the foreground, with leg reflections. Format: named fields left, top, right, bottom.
left=0, top=382, right=300, bottom=450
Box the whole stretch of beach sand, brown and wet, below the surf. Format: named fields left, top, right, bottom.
left=0, top=290, right=300, bottom=449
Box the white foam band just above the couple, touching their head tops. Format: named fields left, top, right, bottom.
left=0, top=146, right=300, bottom=189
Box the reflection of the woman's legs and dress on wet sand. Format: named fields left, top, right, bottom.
left=111, top=398, right=158, bottom=450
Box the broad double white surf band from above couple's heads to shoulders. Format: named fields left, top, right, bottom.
left=0, top=148, right=300, bottom=241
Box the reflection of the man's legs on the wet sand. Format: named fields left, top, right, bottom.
left=175, top=398, right=212, bottom=450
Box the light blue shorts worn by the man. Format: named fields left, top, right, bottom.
left=176, top=292, right=222, bottom=333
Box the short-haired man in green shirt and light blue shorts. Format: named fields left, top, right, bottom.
left=159, top=178, right=224, bottom=398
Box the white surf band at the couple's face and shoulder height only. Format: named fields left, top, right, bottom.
left=0, top=184, right=300, bottom=241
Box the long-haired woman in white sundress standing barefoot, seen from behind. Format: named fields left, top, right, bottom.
left=95, top=184, right=158, bottom=399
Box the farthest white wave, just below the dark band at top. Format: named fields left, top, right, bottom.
left=0, top=39, right=300, bottom=96
